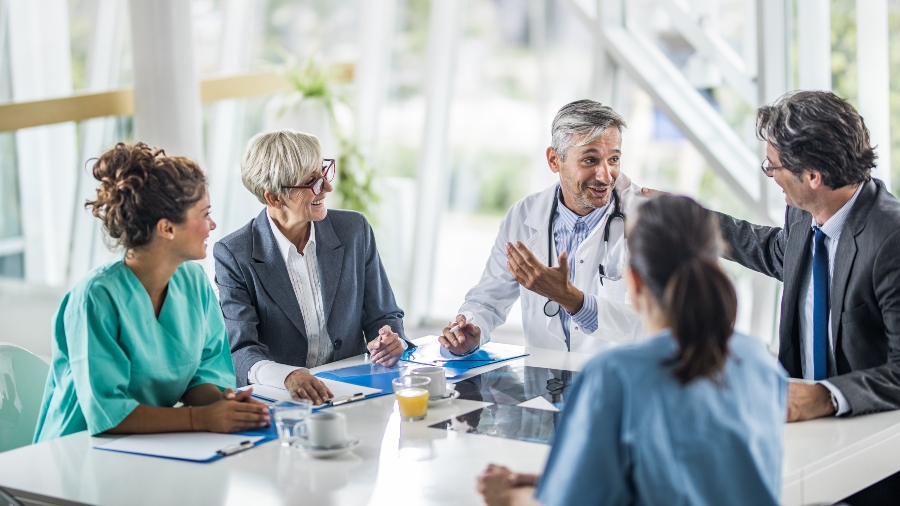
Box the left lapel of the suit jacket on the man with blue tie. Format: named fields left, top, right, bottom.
left=778, top=212, right=813, bottom=377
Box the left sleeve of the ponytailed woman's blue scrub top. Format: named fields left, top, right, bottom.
left=537, top=363, right=635, bottom=506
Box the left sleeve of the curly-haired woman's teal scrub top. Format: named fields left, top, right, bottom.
left=65, top=285, right=138, bottom=435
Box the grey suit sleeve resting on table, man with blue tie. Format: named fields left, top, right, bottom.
left=828, top=230, right=900, bottom=415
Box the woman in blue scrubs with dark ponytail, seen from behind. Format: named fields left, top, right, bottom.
left=479, top=196, right=787, bottom=506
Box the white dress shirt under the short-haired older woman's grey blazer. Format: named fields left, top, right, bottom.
left=247, top=213, right=334, bottom=388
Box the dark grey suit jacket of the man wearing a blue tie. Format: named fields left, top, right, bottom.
left=719, top=179, right=900, bottom=415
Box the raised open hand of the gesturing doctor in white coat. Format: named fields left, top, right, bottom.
left=506, top=241, right=584, bottom=314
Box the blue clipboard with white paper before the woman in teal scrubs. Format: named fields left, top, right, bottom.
left=94, top=423, right=278, bottom=464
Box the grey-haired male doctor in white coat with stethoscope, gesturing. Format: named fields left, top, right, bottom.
left=438, top=100, right=644, bottom=355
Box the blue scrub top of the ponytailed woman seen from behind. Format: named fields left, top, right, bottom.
left=537, top=331, right=787, bottom=506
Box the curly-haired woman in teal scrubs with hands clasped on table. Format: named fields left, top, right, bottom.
left=34, top=143, right=269, bottom=442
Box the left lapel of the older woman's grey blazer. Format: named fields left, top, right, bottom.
left=252, top=209, right=306, bottom=339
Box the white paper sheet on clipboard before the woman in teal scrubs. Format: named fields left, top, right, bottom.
left=94, top=432, right=263, bottom=462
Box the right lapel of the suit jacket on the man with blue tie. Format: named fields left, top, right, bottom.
left=831, top=182, right=876, bottom=374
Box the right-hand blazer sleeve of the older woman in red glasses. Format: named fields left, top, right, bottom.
left=362, top=221, right=416, bottom=350
